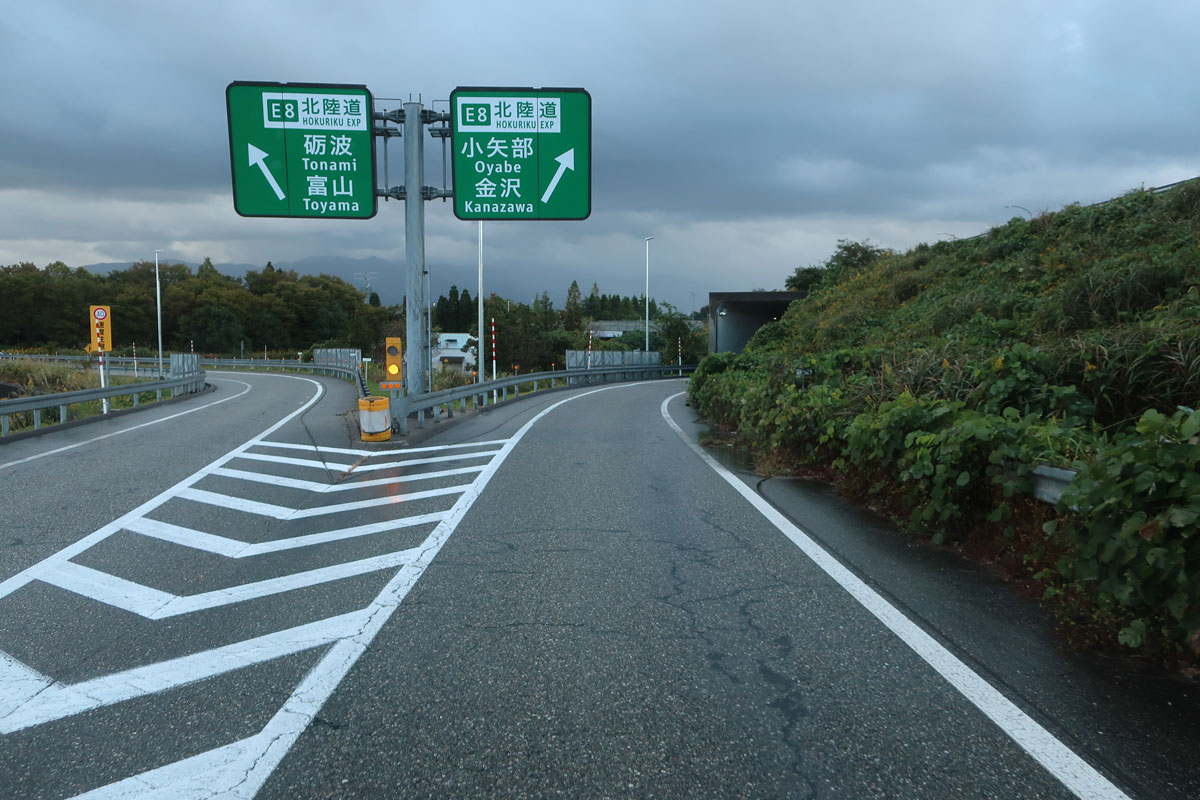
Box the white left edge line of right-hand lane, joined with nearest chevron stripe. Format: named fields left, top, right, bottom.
left=76, top=384, right=638, bottom=800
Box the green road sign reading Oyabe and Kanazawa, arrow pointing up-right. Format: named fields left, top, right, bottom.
left=450, top=86, right=592, bottom=219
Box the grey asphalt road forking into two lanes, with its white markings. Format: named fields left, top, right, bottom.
left=0, top=374, right=1200, bottom=799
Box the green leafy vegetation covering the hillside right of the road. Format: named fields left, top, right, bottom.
left=691, top=181, right=1200, bottom=658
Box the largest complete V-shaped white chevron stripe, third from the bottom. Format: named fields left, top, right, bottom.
left=38, top=548, right=418, bottom=619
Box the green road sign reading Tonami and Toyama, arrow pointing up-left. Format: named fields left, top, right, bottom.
left=226, top=82, right=377, bottom=219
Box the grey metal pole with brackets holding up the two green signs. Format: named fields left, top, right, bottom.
left=374, top=102, right=452, bottom=434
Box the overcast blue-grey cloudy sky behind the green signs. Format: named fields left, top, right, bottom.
left=0, top=0, right=1200, bottom=309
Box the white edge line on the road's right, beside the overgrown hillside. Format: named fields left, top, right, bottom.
left=660, top=392, right=1129, bottom=800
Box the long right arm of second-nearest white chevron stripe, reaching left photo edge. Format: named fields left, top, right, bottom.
left=0, top=610, right=366, bottom=734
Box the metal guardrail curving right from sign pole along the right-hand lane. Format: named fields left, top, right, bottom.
left=391, top=363, right=696, bottom=434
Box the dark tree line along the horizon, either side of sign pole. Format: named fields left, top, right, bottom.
left=0, top=266, right=707, bottom=372
